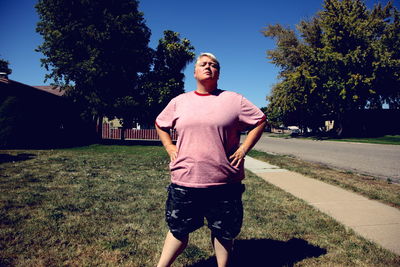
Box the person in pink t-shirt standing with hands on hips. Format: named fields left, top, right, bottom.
left=156, top=53, right=266, bottom=267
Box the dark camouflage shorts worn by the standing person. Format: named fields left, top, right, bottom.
left=165, top=184, right=245, bottom=240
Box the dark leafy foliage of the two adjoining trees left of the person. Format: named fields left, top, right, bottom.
left=36, top=0, right=193, bottom=130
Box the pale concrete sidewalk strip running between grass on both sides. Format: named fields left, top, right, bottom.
left=245, top=156, right=400, bottom=255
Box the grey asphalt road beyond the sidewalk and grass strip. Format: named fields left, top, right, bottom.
left=250, top=135, right=400, bottom=183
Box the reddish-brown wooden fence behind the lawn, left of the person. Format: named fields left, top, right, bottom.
left=102, top=123, right=178, bottom=141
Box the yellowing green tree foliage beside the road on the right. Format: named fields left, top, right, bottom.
left=264, top=0, right=400, bottom=136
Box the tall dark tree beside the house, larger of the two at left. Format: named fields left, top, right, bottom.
left=36, top=0, right=152, bottom=138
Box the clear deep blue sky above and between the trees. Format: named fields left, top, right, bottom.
left=0, top=0, right=399, bottom=107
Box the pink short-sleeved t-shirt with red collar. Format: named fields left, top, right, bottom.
left=156, top=90, right=266, bottom=188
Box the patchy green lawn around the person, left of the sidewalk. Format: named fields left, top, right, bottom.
left=0, top=145, right=400, bottom=267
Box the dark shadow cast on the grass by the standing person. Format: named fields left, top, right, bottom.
left=190, top=238, right=327, bottom=267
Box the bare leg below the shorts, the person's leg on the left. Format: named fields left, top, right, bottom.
left=157, top=231, right=189, bottom=267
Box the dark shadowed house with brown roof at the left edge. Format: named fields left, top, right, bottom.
left=0, top=76, right=90, bottom=148
